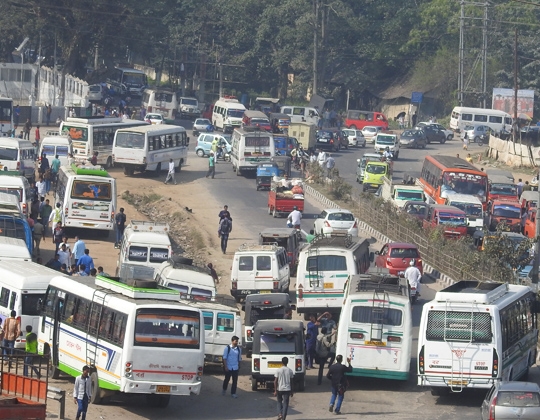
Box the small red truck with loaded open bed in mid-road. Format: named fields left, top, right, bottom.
left=268, top=178, right=304, bottom=217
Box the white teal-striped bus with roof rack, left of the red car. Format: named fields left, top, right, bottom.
left=296, top=235, right=370, bottom=319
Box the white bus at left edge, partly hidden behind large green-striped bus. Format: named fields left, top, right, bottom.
left=0, top=260, right=64, bottom=349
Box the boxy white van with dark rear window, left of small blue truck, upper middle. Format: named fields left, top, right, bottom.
left=231, top=127, right=276, bottom=176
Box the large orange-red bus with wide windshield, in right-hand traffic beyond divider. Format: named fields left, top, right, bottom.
left=418, top=156, right=488, bottom=210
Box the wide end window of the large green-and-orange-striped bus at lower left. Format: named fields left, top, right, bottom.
left=134, top=308, right=201, bottom=349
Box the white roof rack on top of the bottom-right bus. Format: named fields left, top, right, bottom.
left=435, top=280, right=508, bottom=305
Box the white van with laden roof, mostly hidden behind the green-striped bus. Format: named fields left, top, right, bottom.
left=154, top=258, right=216, bottom=298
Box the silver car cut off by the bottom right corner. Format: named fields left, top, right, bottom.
left=481, top=381, right=540, bottom=420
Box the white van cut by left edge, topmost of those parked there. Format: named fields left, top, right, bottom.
left=0, top=137, right=35, bottom=180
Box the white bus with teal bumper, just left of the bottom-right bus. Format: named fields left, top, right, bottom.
left=336, top=269, right=413, bottom=381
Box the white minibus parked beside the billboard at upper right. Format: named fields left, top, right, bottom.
left=450, top=106, right=512, bottom=133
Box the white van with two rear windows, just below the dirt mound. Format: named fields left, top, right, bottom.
left=116, top=220, right=172, bottom=278
